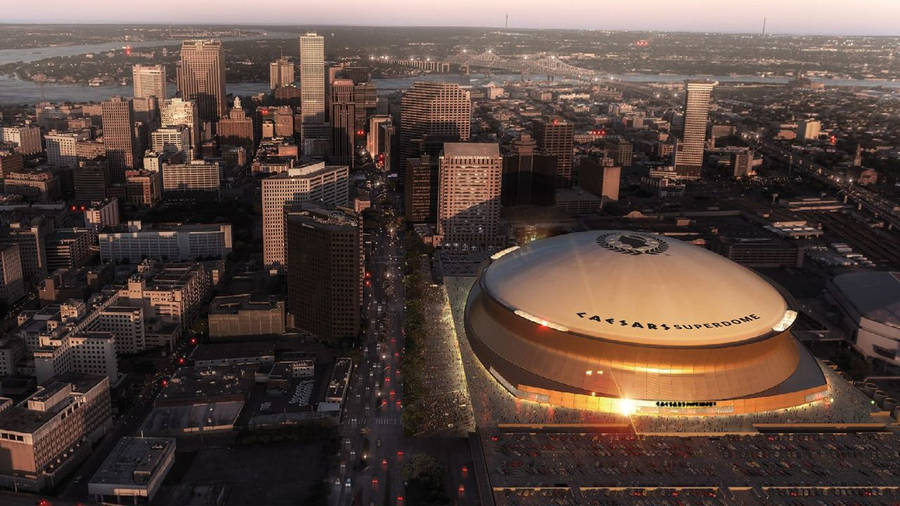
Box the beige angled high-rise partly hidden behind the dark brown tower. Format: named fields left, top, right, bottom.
left=262, top=162, right=350, bottom=268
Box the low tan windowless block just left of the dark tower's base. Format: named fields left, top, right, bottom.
left=209, top=294, right=284, bottom=339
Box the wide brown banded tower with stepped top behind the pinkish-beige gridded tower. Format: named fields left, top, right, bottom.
left=399, top=82, right=472, bottom=168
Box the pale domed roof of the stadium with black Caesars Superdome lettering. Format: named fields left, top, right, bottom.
left=482, top=230, right=792, bottom=347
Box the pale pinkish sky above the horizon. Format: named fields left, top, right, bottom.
left=2, top=0, right=900, bottom=35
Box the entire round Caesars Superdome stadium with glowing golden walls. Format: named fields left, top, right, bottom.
left=465, top=231, right=828, bottom=415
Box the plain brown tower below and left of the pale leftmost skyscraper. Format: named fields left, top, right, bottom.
left=102, top=97, right=140, bottom=183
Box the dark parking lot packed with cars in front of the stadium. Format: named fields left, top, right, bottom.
left=482, top=431, right=900, bottom=487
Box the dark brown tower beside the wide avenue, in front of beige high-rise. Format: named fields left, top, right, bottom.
left=284, top=205, right=364, bottom=342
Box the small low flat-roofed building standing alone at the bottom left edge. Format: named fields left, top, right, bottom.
left=88, top=436, right=175, bottom=504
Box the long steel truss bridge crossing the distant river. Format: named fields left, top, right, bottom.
left=447, top=49, right=601, bottom=81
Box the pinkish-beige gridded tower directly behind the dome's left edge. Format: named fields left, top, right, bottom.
left=437, top=142, right=503, bottom=253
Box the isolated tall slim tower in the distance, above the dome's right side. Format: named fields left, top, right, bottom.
left=675, top=81, right=718, bottom=179
